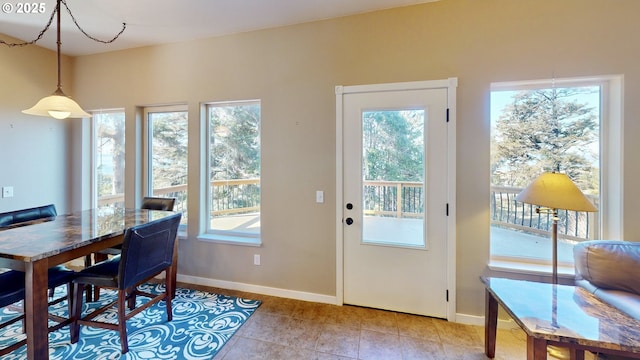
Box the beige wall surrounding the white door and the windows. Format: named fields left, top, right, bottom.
left=0, top=0, right=640, bottom=316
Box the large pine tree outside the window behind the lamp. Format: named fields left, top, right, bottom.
left=491, top=88, right=599, bottom=190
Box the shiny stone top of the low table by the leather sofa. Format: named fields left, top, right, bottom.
left=482, top=277, right=640, bottom=353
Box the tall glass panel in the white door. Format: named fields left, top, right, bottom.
left=362, top=109, right=425, bottom=247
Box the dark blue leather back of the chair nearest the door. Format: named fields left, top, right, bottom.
left=118, top=213, right=182, bottom=289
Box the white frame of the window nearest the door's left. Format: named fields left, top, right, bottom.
left=198, top=99, right=262, bottom=246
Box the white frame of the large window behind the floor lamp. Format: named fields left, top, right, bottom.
left=489, top=75, right=624, bottom=277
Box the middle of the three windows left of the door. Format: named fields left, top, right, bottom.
left=144, top=106, right=188, bottom=222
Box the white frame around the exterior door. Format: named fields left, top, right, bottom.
left=335, top=78, right=458, bottom=322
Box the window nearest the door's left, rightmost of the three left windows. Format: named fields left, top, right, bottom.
left=206, top=101, right=260, bottom=243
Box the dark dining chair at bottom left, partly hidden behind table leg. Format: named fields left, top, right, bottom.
left=0, top=265, right=75, bottom=357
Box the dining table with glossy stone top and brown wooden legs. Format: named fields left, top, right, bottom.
left=0, top=206, right=177, bottom=360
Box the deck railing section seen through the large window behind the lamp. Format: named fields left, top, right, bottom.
left=491, top=186, right=600, bottom=241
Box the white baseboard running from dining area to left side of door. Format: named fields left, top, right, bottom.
left=178, top=274, right=337, bottom=305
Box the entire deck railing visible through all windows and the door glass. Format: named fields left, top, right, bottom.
left=99, top=179, right=599, bottom=241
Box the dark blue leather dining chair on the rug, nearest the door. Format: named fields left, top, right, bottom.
left=71, top=213, right=182, bottom=354
